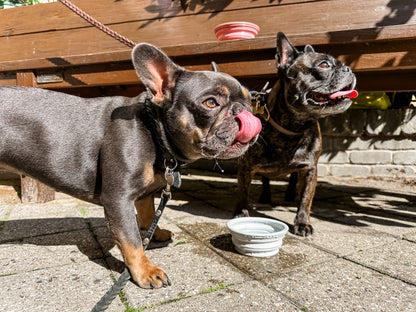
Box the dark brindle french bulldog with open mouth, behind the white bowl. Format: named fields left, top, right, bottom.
left=235, top=33, right=358, bottom=236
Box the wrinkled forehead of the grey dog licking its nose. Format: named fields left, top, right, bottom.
left=176, top=71, right=250, bottom=102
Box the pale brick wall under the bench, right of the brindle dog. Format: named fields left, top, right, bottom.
left=318, top=109, right=416, bottom=177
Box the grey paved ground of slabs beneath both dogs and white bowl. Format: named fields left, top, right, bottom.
left=0, top=175, right=416, bottom=312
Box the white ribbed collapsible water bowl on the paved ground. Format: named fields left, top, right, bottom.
left=227, top=217, right=289, bottom=257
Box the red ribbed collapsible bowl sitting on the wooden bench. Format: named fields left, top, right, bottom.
left=215, top=22, right=260, bottom=41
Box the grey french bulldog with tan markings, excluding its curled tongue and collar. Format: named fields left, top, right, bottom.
left=0, top=44, right=256, bottom=288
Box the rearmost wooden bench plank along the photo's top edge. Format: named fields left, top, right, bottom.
left=0, top=0, right=342, bottom=37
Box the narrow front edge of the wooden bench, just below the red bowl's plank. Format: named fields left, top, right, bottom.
left=0, top=25, right=416, bottom=71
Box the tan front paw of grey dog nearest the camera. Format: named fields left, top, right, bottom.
left=130, top=261, right=172, bottom=289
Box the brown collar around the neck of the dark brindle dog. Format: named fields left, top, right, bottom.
left=250, top=88, right=302, bottom=135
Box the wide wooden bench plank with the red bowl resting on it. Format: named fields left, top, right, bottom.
left=0, top=0, right=416, bottom=61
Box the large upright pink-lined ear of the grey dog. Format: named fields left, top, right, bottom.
left=132, top=43, right=184, bottom=104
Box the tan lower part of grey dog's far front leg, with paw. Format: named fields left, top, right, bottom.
left=134, top=195, right=173, bottom=242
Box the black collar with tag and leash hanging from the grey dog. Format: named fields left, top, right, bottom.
left=91, top=98, right=181, bottom=312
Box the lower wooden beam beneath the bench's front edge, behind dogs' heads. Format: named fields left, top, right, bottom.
left=26, top=42, right=416, bottom=88
